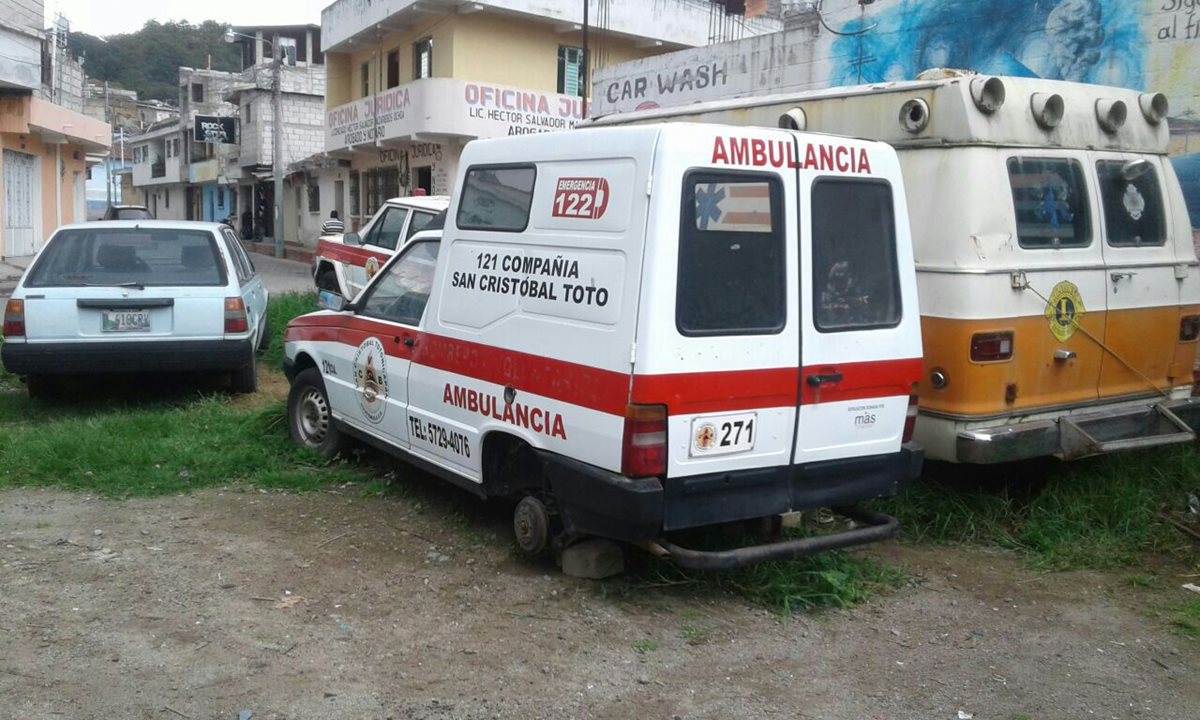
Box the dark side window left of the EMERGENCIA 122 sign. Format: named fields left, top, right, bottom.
left=455, top=166, right=536, bottom=233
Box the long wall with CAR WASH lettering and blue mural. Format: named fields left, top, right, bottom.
left=594, top=0, right=1200, bottom=227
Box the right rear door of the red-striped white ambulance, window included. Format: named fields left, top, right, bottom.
left=793, top=143, right=922, bottom=463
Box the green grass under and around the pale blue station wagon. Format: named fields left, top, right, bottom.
left=0, top=295, right=362, bottom=497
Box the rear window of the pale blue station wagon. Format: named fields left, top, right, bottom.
left=25, top=228, right=226, bottom=288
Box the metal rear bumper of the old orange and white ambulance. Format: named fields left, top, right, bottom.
left=955, top=397, right=1200, bottom=464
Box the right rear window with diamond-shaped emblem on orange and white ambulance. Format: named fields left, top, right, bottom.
left=1096, top=160, right=1166, bottom=247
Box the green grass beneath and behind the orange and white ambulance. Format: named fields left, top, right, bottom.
left=876, top=445, right=1200, bottom=570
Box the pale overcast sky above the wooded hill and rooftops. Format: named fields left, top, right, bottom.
left=46, top=0, right=334, bottom=36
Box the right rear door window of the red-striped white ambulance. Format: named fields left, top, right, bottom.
left=811, top=178, right=901, bottom=332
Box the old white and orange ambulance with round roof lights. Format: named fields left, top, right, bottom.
left=593, top=71, right=1200, bottom=463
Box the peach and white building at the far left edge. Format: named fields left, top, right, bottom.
left=0, top=0, right=112, bottom=258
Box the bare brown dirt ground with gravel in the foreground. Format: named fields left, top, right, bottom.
left=0, top=477, right=1200, bottom=720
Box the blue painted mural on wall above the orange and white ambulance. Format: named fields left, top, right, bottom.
left=829, top=0, right=1200, bottom=227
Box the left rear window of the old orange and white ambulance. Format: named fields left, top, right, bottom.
left=1008, top=157, right=1092, bottom=250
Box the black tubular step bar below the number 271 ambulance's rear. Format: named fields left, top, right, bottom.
left=658, top=508, right=900, bottom=570
